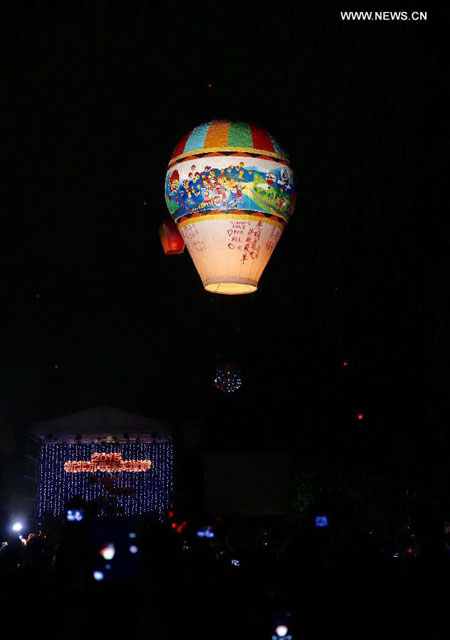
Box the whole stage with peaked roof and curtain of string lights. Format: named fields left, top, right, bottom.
left=30, top=407, right=173, bottom=524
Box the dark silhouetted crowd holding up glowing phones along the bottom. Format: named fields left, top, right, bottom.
left=0, top=498, right=449, bottom=640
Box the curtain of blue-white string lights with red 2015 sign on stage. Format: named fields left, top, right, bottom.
left=38, top=442, right=173, bottom=525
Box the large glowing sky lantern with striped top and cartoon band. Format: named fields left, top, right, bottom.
left=165, top=120, right=295, bottom=295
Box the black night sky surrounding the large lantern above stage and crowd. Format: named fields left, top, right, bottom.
left=0, top=1, right=450, bottom=510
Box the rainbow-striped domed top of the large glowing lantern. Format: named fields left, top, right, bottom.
left=169, top=120, right=289, bottom=167
